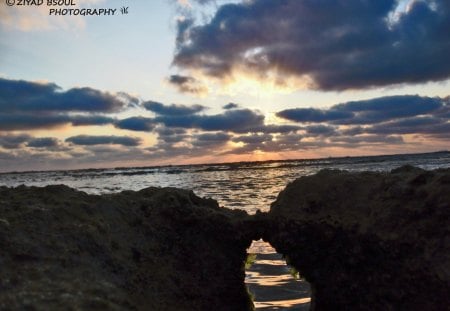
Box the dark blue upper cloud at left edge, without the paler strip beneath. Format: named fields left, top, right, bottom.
left=0, top=78, right=133, bottom=113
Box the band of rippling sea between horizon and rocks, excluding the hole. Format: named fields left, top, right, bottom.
left=0, top=152, right=450, bottom=214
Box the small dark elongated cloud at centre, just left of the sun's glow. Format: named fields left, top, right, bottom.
left=155, top=109, right=264, bottom=132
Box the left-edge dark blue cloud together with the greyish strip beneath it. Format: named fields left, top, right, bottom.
left=0, top=78, right=134, bottom=131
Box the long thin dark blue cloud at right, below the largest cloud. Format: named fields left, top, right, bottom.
left=277, top=95, right=445, bottom=125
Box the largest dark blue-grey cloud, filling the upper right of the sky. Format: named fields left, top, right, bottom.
left=173, top=0, right=450, bottom=90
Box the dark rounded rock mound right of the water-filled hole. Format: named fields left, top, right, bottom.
left=264, top=166, right=450, bottom=310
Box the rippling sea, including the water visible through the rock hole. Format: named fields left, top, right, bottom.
left=0, top=151, right=450, bottom=311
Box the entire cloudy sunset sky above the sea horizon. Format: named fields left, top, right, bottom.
left=0, top=0, right=450, bottom=172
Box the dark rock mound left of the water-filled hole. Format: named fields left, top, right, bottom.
left=0, top=186, right=253, bottom=310
